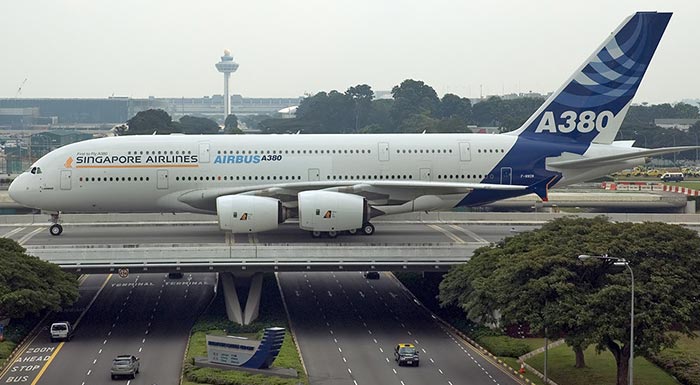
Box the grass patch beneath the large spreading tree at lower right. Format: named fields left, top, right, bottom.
left=527, top=345, right=678, bottom=385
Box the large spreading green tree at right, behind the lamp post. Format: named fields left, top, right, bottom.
left=440, top=218, right=700, bottom=385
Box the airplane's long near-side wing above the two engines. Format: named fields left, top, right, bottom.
left=178, top=180, right=528, bottom=212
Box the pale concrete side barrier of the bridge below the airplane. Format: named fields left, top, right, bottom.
left=27, top=242, right=487, bottom=273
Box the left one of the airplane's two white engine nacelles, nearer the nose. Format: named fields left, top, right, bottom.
left=216, top=195, right=285, bottom=233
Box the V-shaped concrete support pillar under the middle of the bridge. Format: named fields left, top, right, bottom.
left=219, top=272, right=263, bottom=325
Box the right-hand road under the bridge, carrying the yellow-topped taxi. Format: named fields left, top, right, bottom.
left=278, top=272, right=518, bottom=385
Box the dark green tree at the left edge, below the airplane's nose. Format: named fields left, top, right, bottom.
left=0, top=238, right=78, bottom=319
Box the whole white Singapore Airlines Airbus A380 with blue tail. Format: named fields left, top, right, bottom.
left=9, top=12, right=696, bottom=238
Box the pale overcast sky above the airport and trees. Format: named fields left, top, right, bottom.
left=0, top=0, right=700, bottom=103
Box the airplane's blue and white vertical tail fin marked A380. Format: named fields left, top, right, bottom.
left=511, top=12, right=671, bottom=144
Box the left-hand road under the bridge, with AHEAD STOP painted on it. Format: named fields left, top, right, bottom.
left=0, top=274, right=216, bottom=385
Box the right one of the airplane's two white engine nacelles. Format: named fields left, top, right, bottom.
left=298, top=191, right=369, bottom=231
